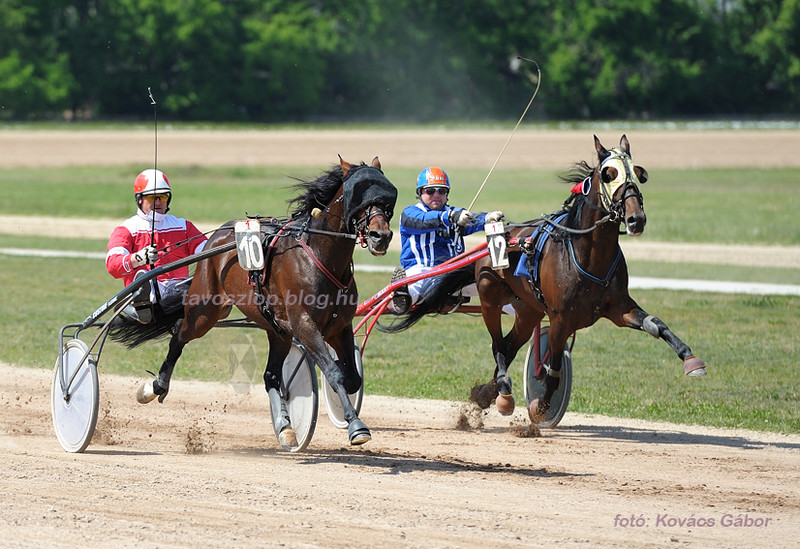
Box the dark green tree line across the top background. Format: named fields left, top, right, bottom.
left=0, top=0, right=800, bottom=122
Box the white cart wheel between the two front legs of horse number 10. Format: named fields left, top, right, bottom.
left=270, top=341, right=319, bottom=452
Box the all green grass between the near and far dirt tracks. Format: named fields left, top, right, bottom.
left=0, top=163, right=800, bottom=432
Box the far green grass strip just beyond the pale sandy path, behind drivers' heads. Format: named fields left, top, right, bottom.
left=6, top=166, right=800, bottom=245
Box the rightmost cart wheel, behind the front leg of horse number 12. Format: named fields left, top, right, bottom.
left=524, top=326, right=572, bottom=429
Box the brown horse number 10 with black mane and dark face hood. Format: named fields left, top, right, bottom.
left=111, top=157, right=397, bottom=447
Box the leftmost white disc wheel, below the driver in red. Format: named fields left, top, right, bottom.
left=50, top=339, right=100, bottom=452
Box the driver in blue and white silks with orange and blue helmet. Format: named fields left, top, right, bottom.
left=392, top=166, right=503, bottom=314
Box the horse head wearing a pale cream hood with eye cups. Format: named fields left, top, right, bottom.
left=594, top=135, right=647, bottom=236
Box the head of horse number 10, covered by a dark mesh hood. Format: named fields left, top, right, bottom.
left=339, top=156, right=397, bottom=256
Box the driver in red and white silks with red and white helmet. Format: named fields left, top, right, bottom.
left=106, top=169, right=208, bottom=302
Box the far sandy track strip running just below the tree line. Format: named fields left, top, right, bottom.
left=0, top=124, right=800, bottom=168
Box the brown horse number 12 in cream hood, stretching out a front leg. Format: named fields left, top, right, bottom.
left=388, top=135, right=706, bottom=423
